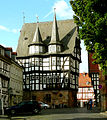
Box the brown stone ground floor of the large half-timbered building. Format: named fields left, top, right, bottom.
left=23, top=90, right=77, bottom=108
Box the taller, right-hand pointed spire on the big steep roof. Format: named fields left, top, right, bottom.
left=50, top=8, right=59, bottom=44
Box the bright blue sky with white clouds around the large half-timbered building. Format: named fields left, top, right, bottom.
left=0, top=0, right=88, bottom=72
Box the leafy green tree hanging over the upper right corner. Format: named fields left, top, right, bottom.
left=70, top=0, right=107, bottom=71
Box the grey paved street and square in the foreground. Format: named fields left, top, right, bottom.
left=0, top=108, right=107, bottom=120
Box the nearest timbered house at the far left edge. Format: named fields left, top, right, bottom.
left=0, top=45, right=11, bottom=114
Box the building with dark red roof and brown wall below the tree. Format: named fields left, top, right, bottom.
left=88, top=53, right=107, bottom=111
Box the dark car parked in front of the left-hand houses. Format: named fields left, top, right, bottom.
left=6, top=101, right=42, bottom=115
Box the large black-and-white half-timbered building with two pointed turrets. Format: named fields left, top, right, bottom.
left=17, top=14, right=81, bottom=107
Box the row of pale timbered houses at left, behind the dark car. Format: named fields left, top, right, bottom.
left=0, top=45, right=23, bottom=114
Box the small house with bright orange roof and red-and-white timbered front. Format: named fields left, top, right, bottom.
left=77, top=73, right=95, bottom=107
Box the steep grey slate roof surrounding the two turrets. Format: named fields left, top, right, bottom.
left=17, top=19, right=77, bottom=57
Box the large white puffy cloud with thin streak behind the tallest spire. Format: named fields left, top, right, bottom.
left=44, top=0, right=74, bottom=19
